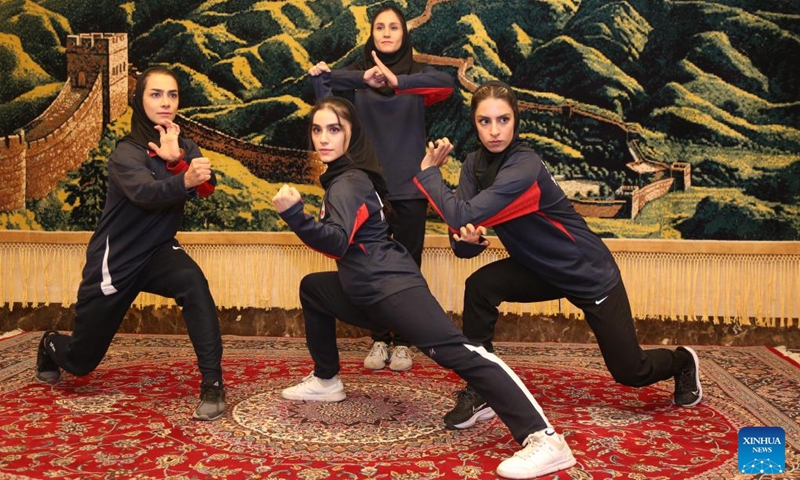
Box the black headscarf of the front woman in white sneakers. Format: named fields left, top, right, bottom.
left=312, top=97, right=388, bottom=199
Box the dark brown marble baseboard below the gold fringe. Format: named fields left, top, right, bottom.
left=0, top=304, right=800, bottom=350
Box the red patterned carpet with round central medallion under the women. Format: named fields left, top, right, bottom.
left=0, top=332, right=800, bottom=480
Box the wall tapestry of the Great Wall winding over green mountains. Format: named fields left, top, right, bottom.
left=0, top=0, right=800, bottom=240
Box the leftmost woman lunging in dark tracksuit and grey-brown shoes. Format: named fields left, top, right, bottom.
left=36, top=67, right=225, bottom=420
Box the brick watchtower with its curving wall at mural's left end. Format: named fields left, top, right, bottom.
left=0, top=33, right=128, bottom=211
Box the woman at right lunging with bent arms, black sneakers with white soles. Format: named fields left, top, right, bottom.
left=415, top=82, right=702, bottom=436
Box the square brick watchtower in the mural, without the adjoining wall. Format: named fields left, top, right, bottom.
left=66, top=33, right=128, bottom=125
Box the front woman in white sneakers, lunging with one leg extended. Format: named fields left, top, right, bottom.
left=273, top=97, right=575, bottom=478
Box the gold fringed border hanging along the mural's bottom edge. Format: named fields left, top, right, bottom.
left=0, top=230, right=800, bottom=327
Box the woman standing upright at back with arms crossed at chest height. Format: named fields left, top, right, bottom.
left=309, top=5, right=453, bottom=371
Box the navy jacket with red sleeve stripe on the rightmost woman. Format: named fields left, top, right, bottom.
left=414, top=148, right=621, bottom=299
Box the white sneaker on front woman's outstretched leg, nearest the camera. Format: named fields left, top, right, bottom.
left=497, top=429, right=575, bottom=478
